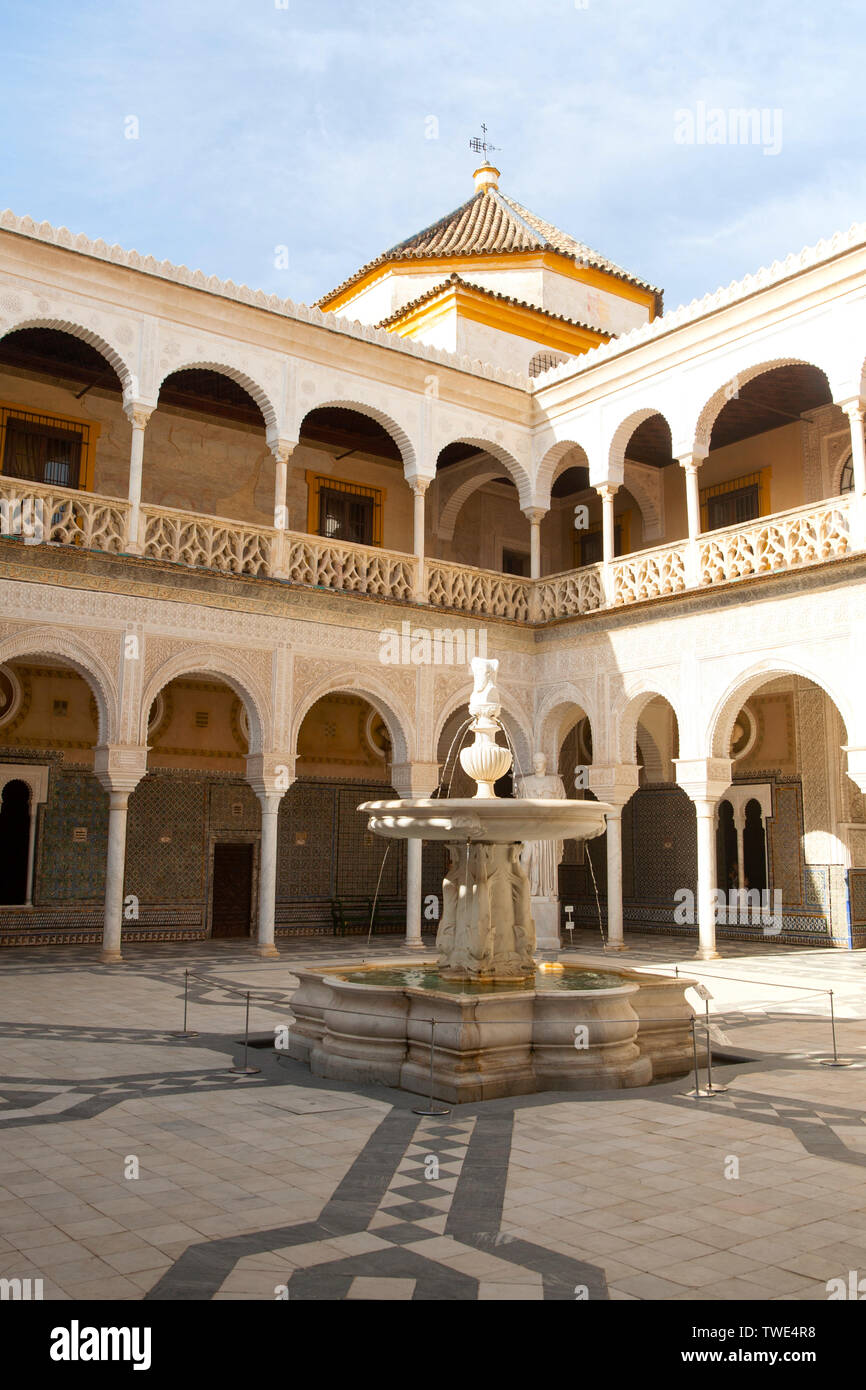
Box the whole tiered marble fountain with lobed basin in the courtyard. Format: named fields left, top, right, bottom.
left=289, top=657, right=694, bottom=1102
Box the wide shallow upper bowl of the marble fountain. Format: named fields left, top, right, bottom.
left=357, top=796, right=613, bottom=845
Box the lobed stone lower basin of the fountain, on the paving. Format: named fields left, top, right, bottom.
left=289, top=958, right=694, bottom=1104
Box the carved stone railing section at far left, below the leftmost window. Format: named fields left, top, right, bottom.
left=0, top=477, right=129, bottom=555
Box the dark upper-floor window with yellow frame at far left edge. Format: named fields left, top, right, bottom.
left=0, top=406, right=99, bottom=488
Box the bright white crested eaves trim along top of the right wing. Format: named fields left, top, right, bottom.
left=530, top=222, right=866, bottom=392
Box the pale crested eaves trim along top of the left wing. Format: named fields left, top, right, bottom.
left=0, top=209, right=531, bottom=392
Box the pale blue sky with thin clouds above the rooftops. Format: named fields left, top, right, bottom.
left=0, top=0, right=866, bottom=309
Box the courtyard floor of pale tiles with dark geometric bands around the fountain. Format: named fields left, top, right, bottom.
left=0, top=935, right=866, bottom=1301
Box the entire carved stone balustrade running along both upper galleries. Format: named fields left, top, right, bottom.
left=0, top=475, right=856, bottom=623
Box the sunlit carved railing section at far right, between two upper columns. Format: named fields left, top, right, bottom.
left=698, top=496, right=851, bottom=585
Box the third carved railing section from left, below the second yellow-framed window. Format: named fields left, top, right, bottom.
left=282, top=531, right=418, bottom=599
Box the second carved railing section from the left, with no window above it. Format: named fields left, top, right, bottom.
left=142, top=506, right=277, bottom=577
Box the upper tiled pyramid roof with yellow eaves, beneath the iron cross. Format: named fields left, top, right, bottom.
left=317, top=188, right=662, bottom=313
